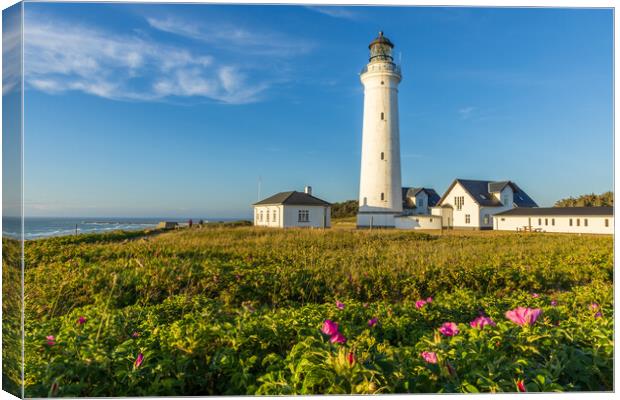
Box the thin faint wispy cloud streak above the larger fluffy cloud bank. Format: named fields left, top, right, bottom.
left=146, top=16, right=314, bottom=57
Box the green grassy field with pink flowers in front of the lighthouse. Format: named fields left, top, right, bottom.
left=15, top=227, right=613, bottom=397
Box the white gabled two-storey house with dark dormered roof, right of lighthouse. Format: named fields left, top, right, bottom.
left=431, top=179, right=538, bottom=229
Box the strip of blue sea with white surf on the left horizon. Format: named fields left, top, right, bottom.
left=2, top=217, right=247, bottom=240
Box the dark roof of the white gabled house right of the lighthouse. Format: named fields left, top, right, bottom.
left=438, top=179, right=538, bottom=207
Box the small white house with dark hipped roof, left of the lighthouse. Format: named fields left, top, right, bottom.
left=253, top=186, right=331, bottom=228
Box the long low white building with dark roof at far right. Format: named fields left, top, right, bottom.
left=494, top=207, right=614, bottom=234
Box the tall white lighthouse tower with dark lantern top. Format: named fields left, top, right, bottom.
left=357, top=32, right=403, bottom=228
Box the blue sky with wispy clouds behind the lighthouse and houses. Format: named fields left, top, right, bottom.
left=18, top=3, right=613, bottom=217
